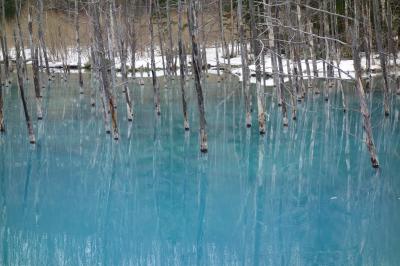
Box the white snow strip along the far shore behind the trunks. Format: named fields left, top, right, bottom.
left=0, top=45, right=394, bottom=86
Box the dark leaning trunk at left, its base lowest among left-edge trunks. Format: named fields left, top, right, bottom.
left=14, top=30, right=36, bottom=144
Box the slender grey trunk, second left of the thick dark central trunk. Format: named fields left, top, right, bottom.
left=149, top=0, right=162, bottom=115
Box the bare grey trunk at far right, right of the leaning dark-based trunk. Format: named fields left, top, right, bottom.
left=372, top=0, right=390, bottom=116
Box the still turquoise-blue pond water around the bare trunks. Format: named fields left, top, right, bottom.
left=0, top=75, right=400, bottom=265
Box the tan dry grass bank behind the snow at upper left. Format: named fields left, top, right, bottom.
left=6, top=2, right=238, bottom=55
